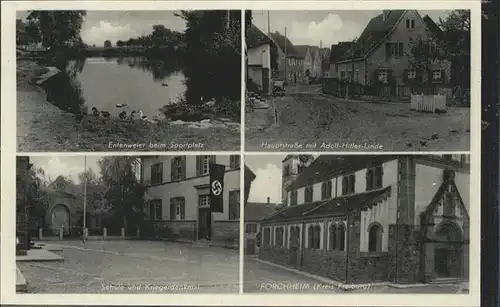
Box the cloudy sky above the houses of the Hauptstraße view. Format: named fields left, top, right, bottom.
left=252, top=10, right=447, bottom=47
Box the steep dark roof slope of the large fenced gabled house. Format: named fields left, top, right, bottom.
left=336, top=10, right=406, bottom=61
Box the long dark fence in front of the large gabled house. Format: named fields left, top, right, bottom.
left=323, top=78, right=453, bottom=100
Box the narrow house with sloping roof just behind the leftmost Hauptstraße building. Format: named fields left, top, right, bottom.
left=269, top=32, right=304, bottom=84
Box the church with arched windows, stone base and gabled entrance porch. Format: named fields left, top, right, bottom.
left=259, top=155, right=470, bottom=284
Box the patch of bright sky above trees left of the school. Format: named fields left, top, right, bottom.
left=30, top=156, right=102, bottom=184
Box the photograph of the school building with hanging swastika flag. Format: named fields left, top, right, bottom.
left=16, top=155, right=240, bottom=295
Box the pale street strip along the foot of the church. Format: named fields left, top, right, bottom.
left=243, top=257, right=466, bottom=294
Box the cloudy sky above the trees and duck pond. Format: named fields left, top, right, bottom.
left=17, top=11, right=186, bottom=46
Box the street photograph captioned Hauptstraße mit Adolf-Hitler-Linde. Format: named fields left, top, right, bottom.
left=245, top=10, right=470, bottom=152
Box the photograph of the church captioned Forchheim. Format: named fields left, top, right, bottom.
left=243, top=154, right=474, bottom=294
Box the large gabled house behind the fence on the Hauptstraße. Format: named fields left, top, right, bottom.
left=330, top=10, right=451, bottom=91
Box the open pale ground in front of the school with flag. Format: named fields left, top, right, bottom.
left=17, top=241, right=239, bottom=293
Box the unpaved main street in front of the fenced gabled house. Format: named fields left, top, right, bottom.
left=245, top=85, right=470, bottom=151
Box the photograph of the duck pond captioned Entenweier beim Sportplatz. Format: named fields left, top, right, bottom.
left=16, top=10, right=242, bottom=152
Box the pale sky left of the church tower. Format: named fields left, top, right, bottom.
left=245, top=155, right=286, bottom=203
